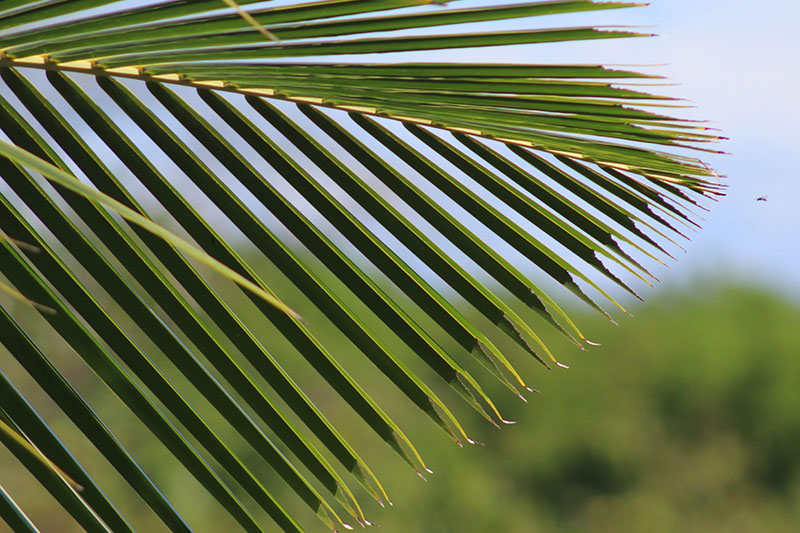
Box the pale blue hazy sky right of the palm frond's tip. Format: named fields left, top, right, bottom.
left=432, top=0, right=800, bottom=298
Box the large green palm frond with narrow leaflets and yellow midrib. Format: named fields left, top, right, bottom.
left=0, top=0, right=722, bottom=531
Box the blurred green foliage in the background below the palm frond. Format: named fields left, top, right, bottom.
left=0, top=285, right=800, bottom=533
